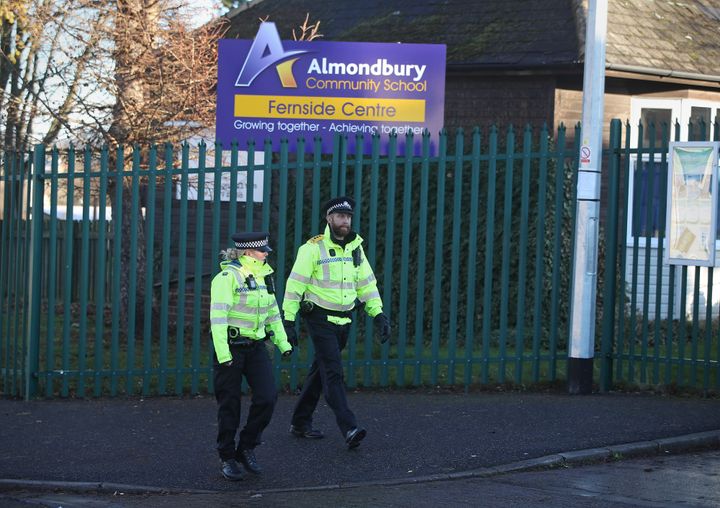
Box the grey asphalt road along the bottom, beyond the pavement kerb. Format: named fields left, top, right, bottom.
left=7, top=450, right=720, bottom=508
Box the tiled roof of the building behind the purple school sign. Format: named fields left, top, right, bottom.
left=228, top=0, right=720, bottom=76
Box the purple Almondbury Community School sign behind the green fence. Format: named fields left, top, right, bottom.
left=215, top=22, right=445, bottom=154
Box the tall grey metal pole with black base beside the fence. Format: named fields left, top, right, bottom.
left=568, top=0, right=607, bottom=394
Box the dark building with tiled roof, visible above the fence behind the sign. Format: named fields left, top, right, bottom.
left=226, top=0, right=720, bottom=143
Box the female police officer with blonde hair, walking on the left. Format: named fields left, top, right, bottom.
left=210, top=232, right=293, bottom=481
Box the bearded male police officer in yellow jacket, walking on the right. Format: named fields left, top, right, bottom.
left=283, top=196, right=390, bottom=449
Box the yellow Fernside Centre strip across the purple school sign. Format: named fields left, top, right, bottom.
left=234, top=95, right=425, bottom=122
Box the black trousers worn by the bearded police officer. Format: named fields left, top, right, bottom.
left=292, top=312, right=357, bottom=437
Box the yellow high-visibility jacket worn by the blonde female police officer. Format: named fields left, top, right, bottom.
left=210, top=256, right=292, bottom=363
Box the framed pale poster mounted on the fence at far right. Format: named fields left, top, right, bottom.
left=665, top=141, right=720, bottom=266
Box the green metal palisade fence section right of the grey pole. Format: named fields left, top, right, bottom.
left=599, top=119, right=720, bottom=393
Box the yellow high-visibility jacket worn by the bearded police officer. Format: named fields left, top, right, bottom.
left=283, top=226, right=382, bottom=324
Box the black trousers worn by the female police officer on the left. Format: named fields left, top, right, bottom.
left=213, top=341, right=277, bottom=460
